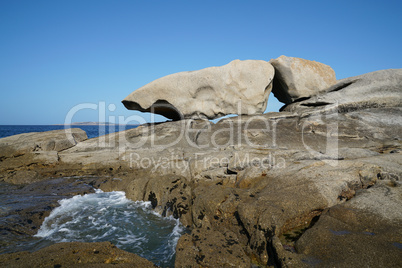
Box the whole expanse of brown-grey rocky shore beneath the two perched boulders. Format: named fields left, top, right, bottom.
left=0, top=56, right=402, bottom=267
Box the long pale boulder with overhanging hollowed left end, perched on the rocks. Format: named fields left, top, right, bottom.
left=123, top=60, right=274, bottom=120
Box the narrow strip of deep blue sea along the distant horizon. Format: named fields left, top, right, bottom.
left=0, top=125, right=137, bottom=139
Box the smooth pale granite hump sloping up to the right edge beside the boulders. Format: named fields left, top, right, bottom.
left=283, top=69, right=402, bottom=114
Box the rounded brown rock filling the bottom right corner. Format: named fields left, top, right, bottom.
left=296, top=183, right=402, bottom=267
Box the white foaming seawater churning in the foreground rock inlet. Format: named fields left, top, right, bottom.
left=35, top=190, right=184, bottom=266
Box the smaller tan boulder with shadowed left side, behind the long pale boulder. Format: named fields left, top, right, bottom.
left=269, top=56, right=336, bottom=104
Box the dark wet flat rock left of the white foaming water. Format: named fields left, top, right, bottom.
left=0, top=178, right=94, bottom=253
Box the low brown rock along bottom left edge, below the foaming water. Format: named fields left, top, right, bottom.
left=0, top=242, right=155, bottom=268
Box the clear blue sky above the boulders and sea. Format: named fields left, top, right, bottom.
left=0, top=0, right=402, bottom=124
